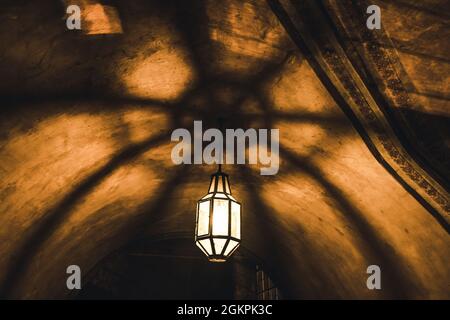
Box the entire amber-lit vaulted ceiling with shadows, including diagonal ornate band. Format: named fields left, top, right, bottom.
left=0, top=0, right=450, bottom=298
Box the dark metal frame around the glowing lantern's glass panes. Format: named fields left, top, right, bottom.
left=195, top=166, right=242, bottom=262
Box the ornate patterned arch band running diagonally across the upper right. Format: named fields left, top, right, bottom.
left=267, top=0, right=450, bottom=233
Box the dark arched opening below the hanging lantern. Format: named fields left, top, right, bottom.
left=76, top=239, right=278, bottom=300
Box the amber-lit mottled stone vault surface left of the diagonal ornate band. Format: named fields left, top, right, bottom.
left=0, top=0, right=450, bottom=298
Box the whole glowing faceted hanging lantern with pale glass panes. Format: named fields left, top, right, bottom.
left=195, top=166, right=241, bottom=262
